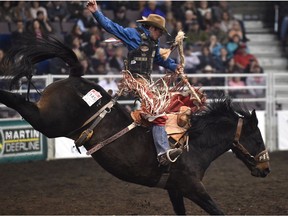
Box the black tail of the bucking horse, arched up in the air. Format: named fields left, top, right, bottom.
left=0, top=35, right=83, bottom=88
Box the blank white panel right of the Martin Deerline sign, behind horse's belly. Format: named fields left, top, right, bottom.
left=55, top=137, right=90, bottom=159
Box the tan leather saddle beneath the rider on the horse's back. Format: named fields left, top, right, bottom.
left=130, top=106, right=192, bottom=150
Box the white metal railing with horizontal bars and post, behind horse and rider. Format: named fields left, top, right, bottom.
left=0, top=73, right=288, bottom=150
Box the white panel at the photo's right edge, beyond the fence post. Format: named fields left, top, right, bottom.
left=277, top=110, right=288, bottom=150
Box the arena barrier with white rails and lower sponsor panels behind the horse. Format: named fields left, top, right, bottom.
left=0, top=71, right=288, bottom=163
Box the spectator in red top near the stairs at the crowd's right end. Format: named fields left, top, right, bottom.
left=234, top=43, right=258, bottom=72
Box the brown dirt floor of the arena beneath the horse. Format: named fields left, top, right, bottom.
left=0, top=151, right=288, bottom=215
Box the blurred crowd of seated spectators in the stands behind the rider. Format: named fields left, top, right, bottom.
left=0, top=0, right=280, bottom=109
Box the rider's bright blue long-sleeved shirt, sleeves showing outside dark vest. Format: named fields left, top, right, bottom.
left=92, top=11, right=177, bottom=71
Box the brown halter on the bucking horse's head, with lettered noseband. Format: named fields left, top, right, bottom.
left=233, top=117, right=269, bottom=166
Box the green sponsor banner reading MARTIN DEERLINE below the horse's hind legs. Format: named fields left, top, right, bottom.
left=0, top=120, right=47, bottom=163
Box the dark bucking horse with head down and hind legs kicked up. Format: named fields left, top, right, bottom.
left=0, top=35, right=269, bottom=214
